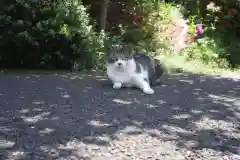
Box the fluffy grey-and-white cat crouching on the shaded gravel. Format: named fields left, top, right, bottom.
left=106, top=48, right=163, bottom=94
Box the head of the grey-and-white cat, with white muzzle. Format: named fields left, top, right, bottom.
left=107, top=47, right=133, bottom=68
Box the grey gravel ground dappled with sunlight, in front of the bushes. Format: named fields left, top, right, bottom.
left=0, top=74, right=240, bottom=160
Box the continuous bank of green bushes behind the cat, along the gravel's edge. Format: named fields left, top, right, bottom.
left=0, top=0, right=240, bottom=69
